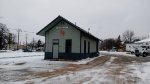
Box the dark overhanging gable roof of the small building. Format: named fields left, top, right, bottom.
left=36, top=15, right=100, bottom=40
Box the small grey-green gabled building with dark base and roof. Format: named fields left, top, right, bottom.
left=37, top=16, right=99, bottom=60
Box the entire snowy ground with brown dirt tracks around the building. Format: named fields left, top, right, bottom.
left=0, top=51, right=150, bottom=84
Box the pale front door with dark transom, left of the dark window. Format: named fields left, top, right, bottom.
left=53, top=39, right=59, bottom=58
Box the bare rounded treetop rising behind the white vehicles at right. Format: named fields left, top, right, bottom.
left=122, top=30, right=134, bottom=43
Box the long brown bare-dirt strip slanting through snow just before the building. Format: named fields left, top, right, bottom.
left=35, top=56, right=111, bottom=78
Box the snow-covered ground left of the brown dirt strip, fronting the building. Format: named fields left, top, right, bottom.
left=0, top=50, right=101, bottom=84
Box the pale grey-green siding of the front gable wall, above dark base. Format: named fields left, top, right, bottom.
left=46, top=22, right=80, bottom=53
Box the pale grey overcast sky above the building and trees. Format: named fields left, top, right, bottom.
left=0, top=0, right=150, bottom=42
